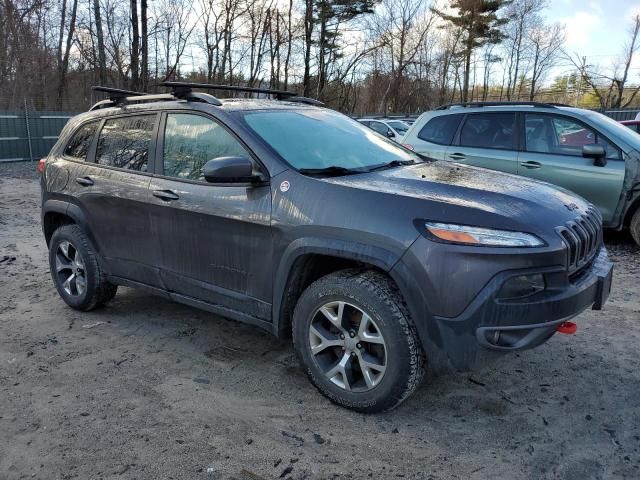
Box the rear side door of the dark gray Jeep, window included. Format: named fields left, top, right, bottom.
left=72, top=113, right=160, bottom=286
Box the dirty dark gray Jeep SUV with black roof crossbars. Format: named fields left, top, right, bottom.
left=42, top=83, right=612, bottom=412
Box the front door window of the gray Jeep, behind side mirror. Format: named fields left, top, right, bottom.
left=163, top=113, right=249, bottom=180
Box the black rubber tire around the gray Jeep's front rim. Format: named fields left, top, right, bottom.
left=292, top=269, right=425, bottom=413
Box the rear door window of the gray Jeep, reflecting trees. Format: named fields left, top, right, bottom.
left=96, top=115, right=157, bottom=172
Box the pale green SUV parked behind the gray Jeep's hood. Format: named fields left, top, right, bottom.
left=402, top=102, right=640, bottom=245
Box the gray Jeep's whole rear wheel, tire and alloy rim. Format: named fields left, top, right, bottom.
left=49, top=225, right=118, bottom=311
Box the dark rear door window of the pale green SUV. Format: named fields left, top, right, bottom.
left=460, top=113, right=516, bottom=150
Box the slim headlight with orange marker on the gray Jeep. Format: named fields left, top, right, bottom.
left=424, top=222, right=544, bottom=247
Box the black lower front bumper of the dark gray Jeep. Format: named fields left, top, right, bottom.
left=390, top=246, right=613, bottom=371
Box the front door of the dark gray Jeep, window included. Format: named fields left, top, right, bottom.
left=149, top=113, right=273, bottom=319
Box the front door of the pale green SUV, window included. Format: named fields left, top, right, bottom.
left=518, top=113, right=625, bottom=223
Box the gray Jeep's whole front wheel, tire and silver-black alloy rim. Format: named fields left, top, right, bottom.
left=293, top=270, right=424, bottom=413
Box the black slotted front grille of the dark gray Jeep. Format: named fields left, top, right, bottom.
left=557, top=208, right=602, bottom=274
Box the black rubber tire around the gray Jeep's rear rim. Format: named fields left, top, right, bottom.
left=49, top=224, right=118, bottom=312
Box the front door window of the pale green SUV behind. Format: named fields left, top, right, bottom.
left=525, top=113, right=620, bottom=159
